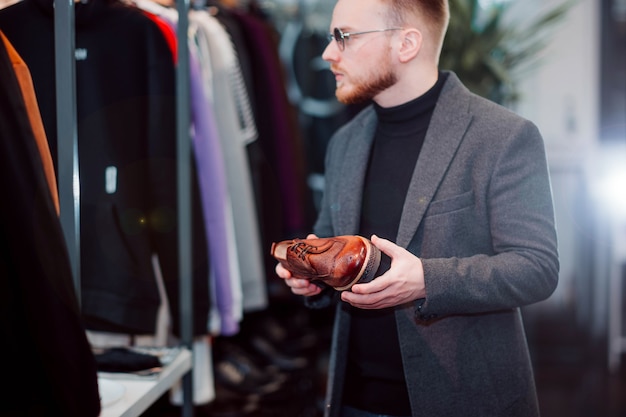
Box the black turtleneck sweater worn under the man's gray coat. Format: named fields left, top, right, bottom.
left=344, top=73, right=445, bottom=416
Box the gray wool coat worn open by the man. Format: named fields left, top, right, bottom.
left=306, top=73, right=559, bottom=417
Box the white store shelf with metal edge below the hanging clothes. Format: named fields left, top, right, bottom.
left=99, top=348, right=192, bottom=417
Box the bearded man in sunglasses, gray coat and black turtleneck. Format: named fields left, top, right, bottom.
left=276, top=0, right=559, bottom=417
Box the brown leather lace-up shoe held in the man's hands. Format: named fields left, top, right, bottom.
left=272, top=235, right=380, bottom=291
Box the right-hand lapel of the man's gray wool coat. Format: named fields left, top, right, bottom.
left=396, top=73, right=471, bottom=248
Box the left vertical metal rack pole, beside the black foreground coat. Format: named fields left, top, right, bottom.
left=54, top=0, right=81, bottom=303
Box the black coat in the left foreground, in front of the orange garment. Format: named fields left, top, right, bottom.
left=0, top=29, right=100, bottom=417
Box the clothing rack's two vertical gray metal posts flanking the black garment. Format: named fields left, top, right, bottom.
left=54, top=0, right=193, bottom=417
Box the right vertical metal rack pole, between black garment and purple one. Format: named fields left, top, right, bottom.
left=176, top=0, right=194, bottom=417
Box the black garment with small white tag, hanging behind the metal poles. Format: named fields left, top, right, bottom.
left=0, top=0, right=209, bottom=334
